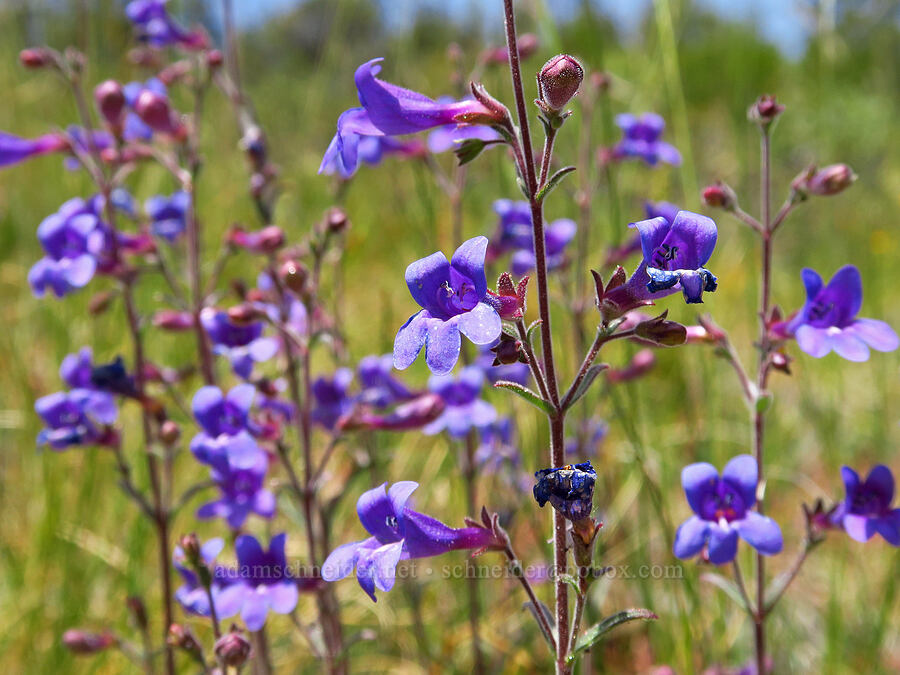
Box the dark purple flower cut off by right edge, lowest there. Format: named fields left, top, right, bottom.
left=831, top=464, right=900, bottom=546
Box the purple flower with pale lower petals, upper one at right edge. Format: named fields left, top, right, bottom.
left=786, top=265, right=900, bottom=361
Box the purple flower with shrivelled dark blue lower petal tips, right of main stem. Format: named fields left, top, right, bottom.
left=604, top=211, right=718, bottom=313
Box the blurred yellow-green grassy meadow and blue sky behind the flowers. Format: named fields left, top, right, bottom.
left=0, top=0, right=900, bottom=674
